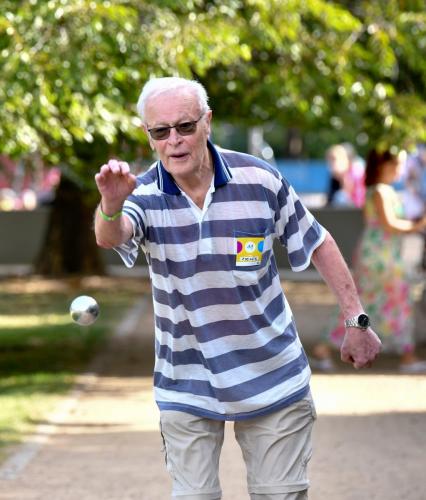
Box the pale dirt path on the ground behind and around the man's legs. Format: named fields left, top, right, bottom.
left=0, top=283, right=426, bottom=500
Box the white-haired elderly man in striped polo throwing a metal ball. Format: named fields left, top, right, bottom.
left=95, top=78, right=380, bottom=500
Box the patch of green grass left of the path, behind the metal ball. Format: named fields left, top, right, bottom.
left=0, top=277, right=148, bottom=460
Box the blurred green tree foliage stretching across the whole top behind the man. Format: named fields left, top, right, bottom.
left=0, top=0, right=426, bottom=172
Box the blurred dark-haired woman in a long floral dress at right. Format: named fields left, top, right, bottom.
left=311, top=146, right=426, bottom=373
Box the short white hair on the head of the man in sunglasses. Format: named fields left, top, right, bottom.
left=136, top=76, right=210, bottom=121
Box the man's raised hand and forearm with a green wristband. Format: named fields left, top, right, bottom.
left=95, top=160, right=136, bottom=248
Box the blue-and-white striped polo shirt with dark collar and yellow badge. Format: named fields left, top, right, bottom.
left=116, top=141, right=326, bottom=420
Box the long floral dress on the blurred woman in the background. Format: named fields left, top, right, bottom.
left=330, top=184, right=414, bottom=354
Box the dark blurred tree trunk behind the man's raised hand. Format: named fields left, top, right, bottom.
left=35, top=177, right=105, bottom=276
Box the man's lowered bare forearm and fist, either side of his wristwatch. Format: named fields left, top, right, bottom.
left=312, top=233, right=381, bottom=368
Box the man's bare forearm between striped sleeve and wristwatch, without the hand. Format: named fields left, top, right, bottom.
left=312, top=233, right=363, bottom=318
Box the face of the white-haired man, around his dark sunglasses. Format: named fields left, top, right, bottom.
left=144, top=89, right=211, bottom=180
